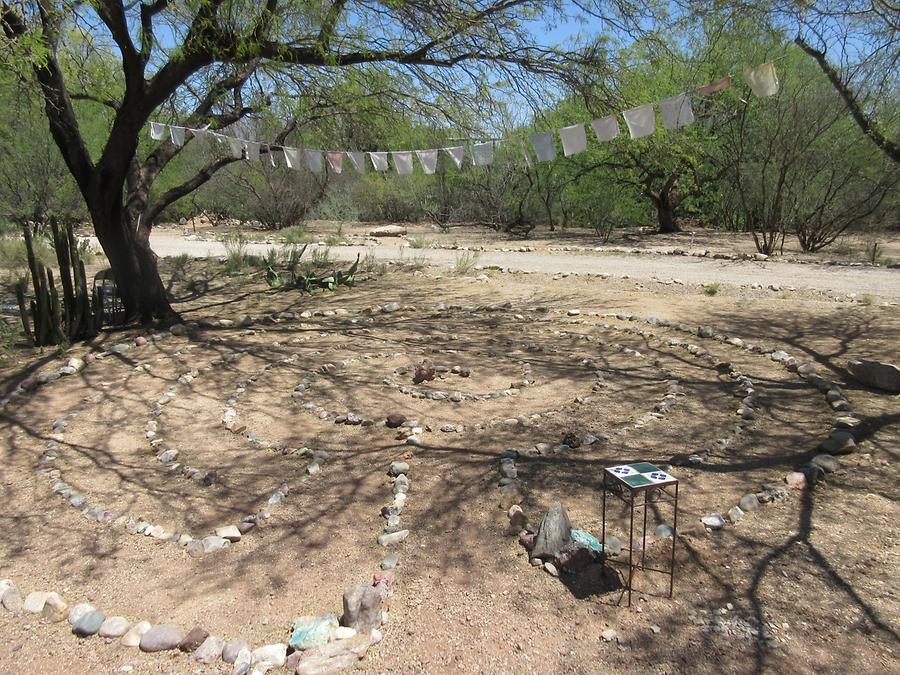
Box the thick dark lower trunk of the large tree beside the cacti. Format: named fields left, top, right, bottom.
left=92, top=204, right=178, bottom=323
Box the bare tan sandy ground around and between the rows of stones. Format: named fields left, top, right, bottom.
left=0, top=255, right=900, bottom=673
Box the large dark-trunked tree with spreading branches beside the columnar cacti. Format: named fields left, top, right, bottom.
left=0, top=0, right=659, bottom=321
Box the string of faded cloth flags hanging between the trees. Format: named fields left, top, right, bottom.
left=150, top=61, right=780, bottom=176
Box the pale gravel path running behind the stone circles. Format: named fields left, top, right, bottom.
left=135, top=234, right=900, bottom=300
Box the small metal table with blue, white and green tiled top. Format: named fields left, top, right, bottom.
left=600, top=462, right=678, bottom=607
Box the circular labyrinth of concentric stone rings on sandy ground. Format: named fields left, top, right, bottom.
left=4, top=298, right=856, bottom=668
